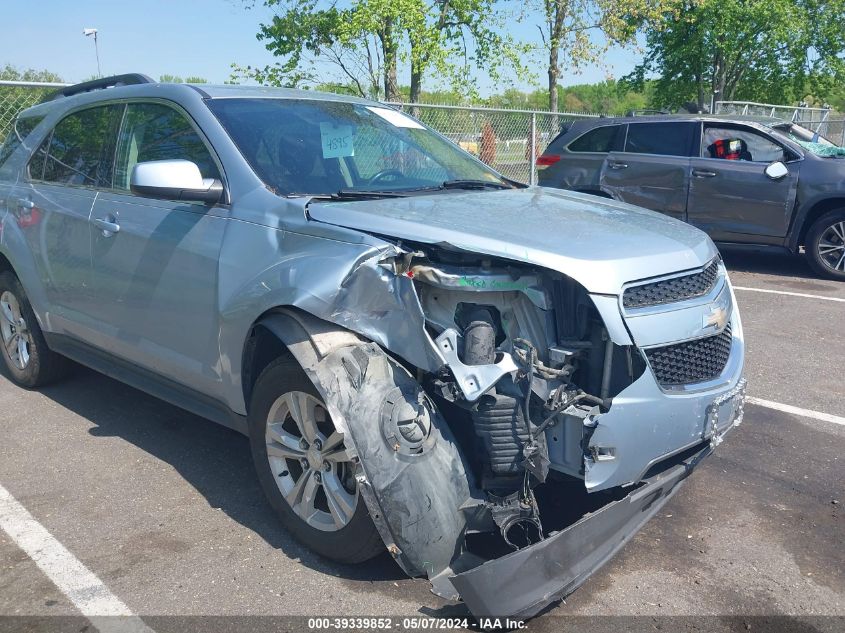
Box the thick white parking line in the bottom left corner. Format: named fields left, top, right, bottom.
left=0, top=485, right=153, bottom=633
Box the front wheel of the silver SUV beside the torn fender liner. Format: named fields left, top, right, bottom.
left=248, top=357, right=384, bottom=563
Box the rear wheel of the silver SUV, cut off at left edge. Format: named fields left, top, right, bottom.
left=0, top=271, right=69, bottom=389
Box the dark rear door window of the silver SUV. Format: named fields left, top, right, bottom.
left=38, top=105, right=122, bottom=187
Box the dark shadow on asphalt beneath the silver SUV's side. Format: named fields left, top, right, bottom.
left=23, top=363, right=407, bottom=582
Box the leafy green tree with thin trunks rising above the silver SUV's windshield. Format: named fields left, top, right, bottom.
left=235, top=0, right=526, bottom=101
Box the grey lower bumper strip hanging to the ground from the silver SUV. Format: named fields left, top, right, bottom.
left=450, top=445, right=713, bottom=618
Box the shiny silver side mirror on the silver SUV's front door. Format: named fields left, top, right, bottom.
left=129, top=160, right=223, bottom=204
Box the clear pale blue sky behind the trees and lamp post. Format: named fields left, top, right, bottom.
left=0, top=0, right=639, bottom=94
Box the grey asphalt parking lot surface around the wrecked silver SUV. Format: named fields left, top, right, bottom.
left=0, top=244, right=845, bottom=631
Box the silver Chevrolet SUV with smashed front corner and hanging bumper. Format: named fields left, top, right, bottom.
left=0, top=75, right=745, bottom=617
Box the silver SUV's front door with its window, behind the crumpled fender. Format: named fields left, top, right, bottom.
left=91, top=102, right=227, bottom=393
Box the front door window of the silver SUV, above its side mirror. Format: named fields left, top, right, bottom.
left=114, top=103, right=220, bottom=190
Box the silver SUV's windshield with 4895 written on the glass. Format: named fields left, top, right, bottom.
left=209, top=99, right=507, bottom=195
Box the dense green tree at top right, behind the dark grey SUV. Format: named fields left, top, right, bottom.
left=626, top=0, right=845, bottom=109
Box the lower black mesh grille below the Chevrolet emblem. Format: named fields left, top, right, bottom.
left=644, top=325, right=733, bottom=387
